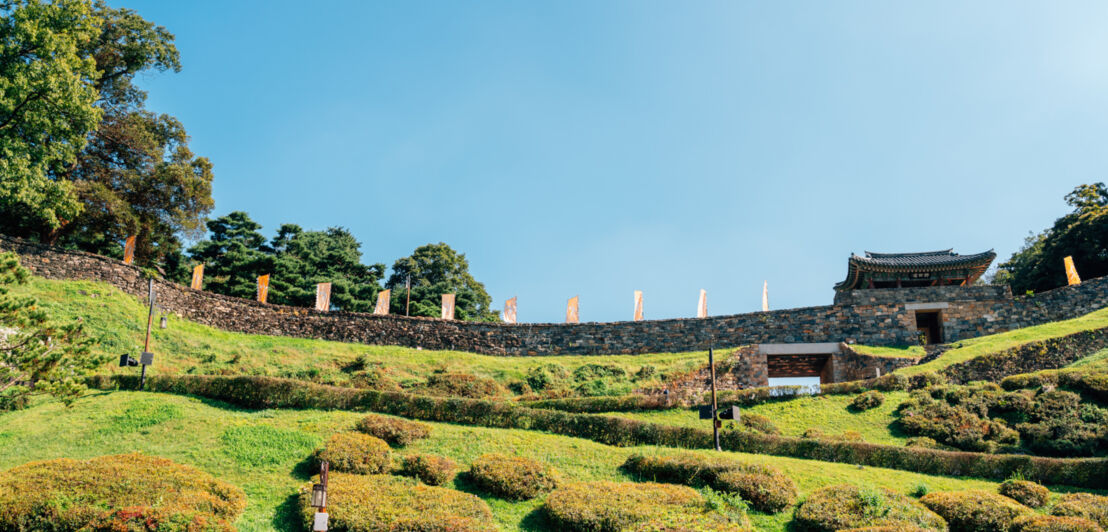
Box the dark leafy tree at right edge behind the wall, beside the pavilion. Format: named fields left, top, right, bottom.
left=994, top=183, right=1108, bottom=294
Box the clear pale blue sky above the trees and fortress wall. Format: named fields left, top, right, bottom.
left=110, top=0, right=1108, bottom=321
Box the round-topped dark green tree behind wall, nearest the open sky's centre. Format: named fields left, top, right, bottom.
left=386, top=242, right=497, bottom=321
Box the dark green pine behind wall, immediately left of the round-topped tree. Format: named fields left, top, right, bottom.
left=269, top=224, right=384, bottom=311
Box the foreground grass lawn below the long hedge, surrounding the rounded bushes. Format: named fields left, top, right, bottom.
left=0, top=391, right=1014, bottom=531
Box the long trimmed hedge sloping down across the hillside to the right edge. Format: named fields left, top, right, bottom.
left=89, top=376, right=1108, bottom=489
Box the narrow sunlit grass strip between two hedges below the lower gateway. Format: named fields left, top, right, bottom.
left=607, top=391, right=907, bottom=446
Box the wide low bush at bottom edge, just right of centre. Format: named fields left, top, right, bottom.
left=543, top=481, right=704, bottom=532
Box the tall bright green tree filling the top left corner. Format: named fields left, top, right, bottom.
left=0, top=0, right=100, bottom=236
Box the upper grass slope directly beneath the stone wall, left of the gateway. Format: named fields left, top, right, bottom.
left=12, top=277, right=707, bottom=386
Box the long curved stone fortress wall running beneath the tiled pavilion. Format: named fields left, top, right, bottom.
left=0, top=236, right=1108, bottom=356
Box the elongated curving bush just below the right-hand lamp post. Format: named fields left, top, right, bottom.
left=623, top=453, right=798, bottom=513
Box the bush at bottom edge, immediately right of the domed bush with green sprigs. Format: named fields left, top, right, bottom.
left=920, top=490, right=1032, bottom=532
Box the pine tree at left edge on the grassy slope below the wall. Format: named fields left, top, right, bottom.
left=0, top=253, right=99, bottom=410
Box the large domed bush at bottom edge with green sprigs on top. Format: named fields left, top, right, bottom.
left=793, top=484, right=946, bottom=532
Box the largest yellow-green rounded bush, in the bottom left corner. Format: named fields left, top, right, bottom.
left=0, top=453, right=246, bottom=532
